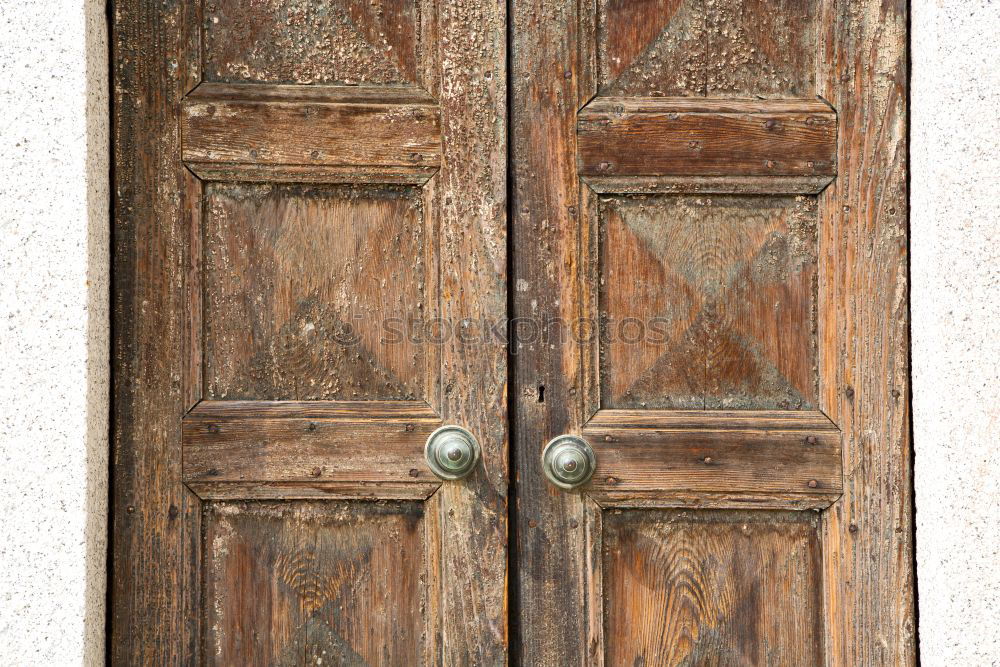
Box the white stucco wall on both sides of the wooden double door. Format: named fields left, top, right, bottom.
left=0, top=0, right=1000, bottom=666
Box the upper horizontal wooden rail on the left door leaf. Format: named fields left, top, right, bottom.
left=181, top=84, right=441, bottom=168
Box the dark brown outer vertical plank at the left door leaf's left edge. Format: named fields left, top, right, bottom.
left=109, top=0, right=195, bottom=665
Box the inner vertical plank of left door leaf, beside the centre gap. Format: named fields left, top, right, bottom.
left=432, top=0, right=508, bottom=665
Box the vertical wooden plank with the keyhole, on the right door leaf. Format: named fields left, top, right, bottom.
left=511, top=0, right=588, bottom=665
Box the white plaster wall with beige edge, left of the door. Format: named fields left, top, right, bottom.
left=0, top=0, right=109, bottom=665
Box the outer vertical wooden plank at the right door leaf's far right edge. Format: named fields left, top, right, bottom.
left=819, top=0, right=916, bottom=665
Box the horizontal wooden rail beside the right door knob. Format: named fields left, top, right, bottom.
left=583, top=410, right=842, bottom=509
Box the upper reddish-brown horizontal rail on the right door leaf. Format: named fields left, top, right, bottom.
left=577, top=98, right=837, bottom=176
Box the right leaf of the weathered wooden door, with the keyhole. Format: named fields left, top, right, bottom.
left=510, top=0, right=915, bottom=665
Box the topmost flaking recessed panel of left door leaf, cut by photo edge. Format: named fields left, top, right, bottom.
left=204, top=0, right=424, bottom=84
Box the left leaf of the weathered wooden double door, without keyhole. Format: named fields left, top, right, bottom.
left=110, top=0, right=508, bottom=665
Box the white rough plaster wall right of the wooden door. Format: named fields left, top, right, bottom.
left=910, top=0, right=1000, bottom=667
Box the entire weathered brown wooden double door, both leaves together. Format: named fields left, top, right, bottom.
left=109, top=0, right=915, bottom=665
